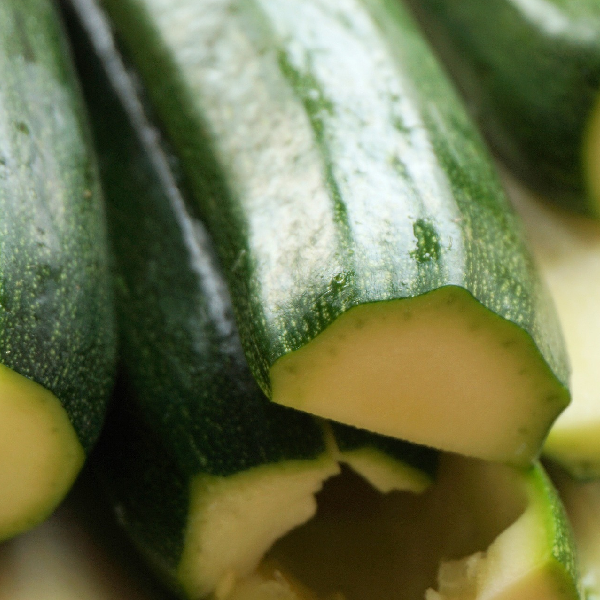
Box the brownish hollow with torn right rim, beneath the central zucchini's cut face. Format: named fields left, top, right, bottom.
left=221, top=456, right=579, bottom=600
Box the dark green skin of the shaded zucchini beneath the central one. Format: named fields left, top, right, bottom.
left=63, top=3, right=332, bottom=589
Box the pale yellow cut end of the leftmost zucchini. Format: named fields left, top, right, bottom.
left=0, top=365, right=84, bottom=540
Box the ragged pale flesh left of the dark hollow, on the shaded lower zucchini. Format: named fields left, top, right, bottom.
left=178, top=457, right=339, bottom=598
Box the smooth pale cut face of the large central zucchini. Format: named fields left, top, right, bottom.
left=271, top=286, right=569, bottom=465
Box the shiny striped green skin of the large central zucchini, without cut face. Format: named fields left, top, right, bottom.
left=104, top=0, right=567, bottom=418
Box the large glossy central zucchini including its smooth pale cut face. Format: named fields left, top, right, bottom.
left=98, top=0, right=569, bottom=464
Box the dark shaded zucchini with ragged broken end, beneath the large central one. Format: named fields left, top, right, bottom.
left=64, top=0, right=435, bottom=598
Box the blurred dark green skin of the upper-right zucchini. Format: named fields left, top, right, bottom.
left=409, top=0, right=600, bottom=217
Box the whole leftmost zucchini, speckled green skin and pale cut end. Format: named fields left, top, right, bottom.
left=0, top=0, right=115, bottom=540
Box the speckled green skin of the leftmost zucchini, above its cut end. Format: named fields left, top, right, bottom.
left=0, top=0, right=115, bottom=453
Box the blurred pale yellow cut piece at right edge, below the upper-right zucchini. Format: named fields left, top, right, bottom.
left=512, top=178, right=600, bottom=479
